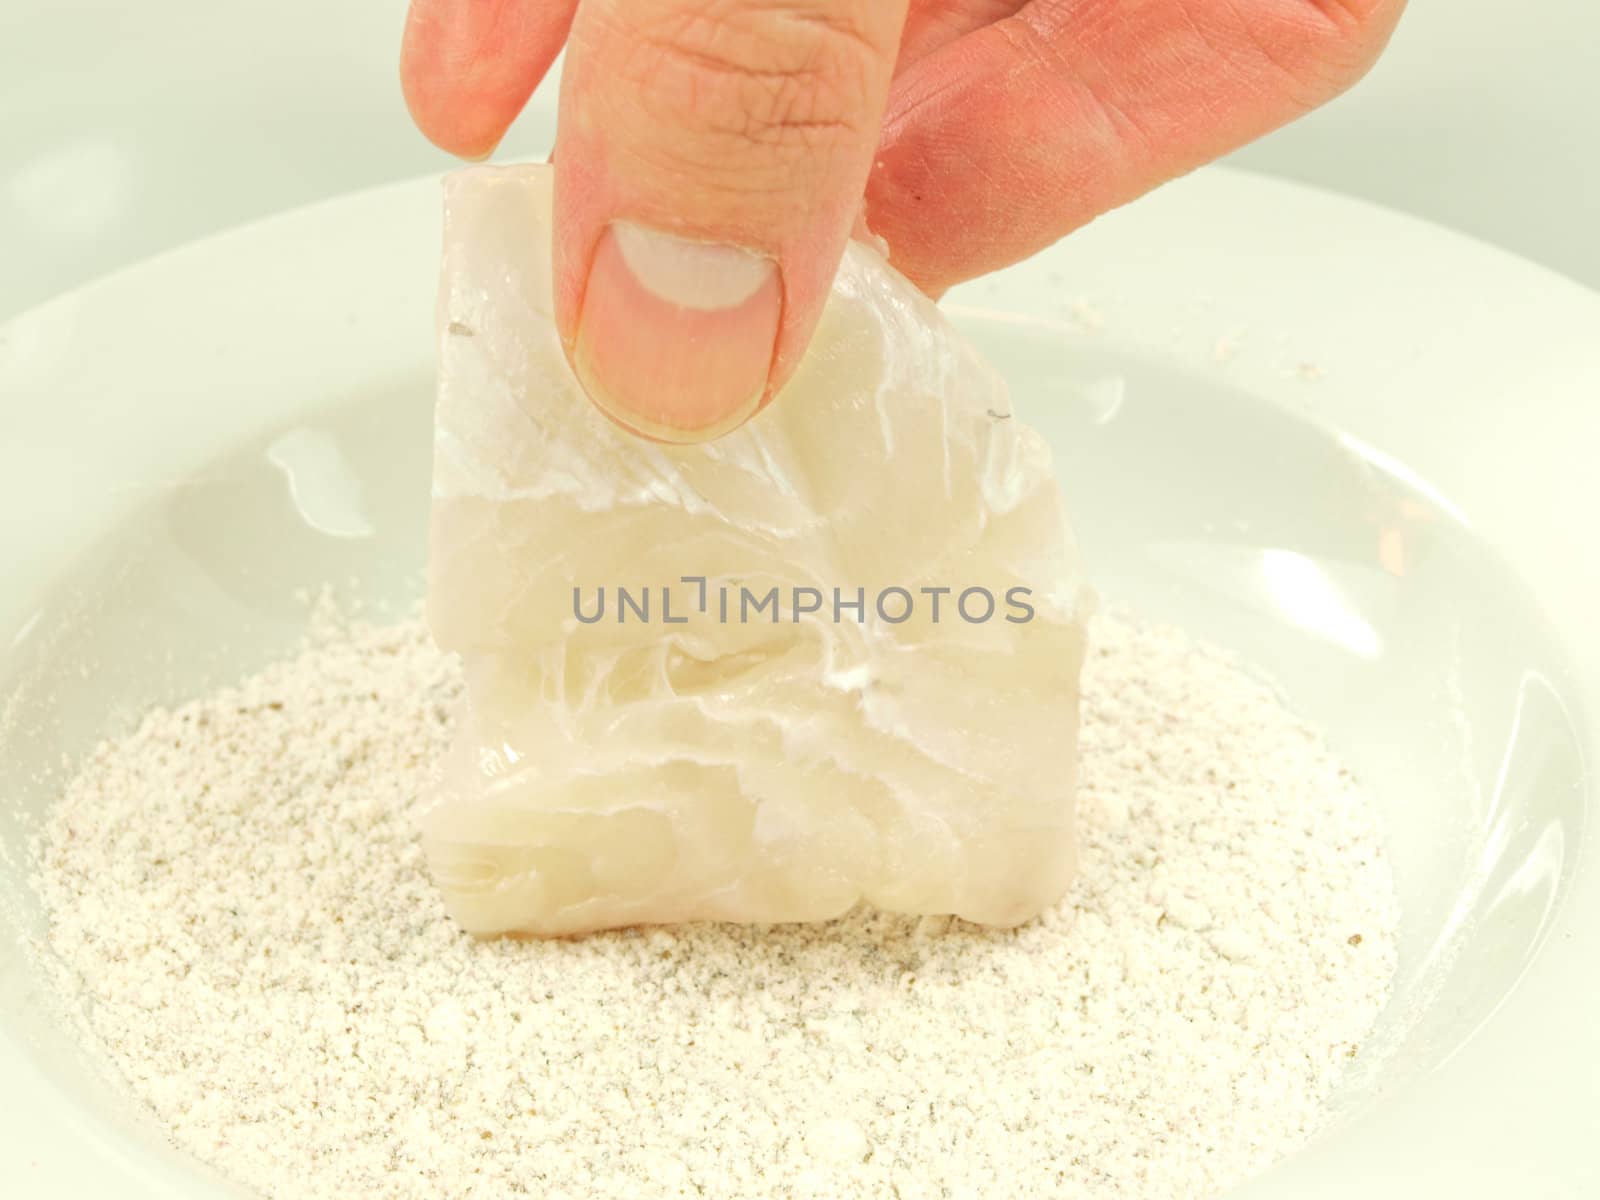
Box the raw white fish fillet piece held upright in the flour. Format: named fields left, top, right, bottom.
left=422, top=166, right=1090, bottom=934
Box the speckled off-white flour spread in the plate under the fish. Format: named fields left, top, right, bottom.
left=34, top=616, right=1397, bottom=1200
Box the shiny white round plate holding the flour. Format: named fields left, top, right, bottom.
left=0, top=170, right=1600, bottom=1197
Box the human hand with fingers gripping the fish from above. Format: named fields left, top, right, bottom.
left=402, top=0, right=1405, bottom=442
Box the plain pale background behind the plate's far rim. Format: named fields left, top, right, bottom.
left=0, top=0, right=1600, bottom=317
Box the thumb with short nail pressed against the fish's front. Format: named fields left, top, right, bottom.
left=555, top=0, right=907, bottom=442
